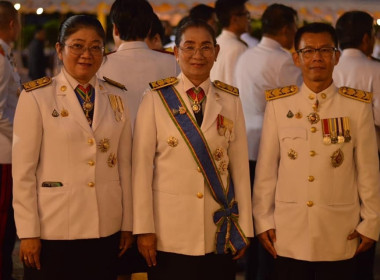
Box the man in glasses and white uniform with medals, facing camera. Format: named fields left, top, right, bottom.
left=253, top=23, right=380, bottom=280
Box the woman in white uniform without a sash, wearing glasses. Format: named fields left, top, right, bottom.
left=13, top=15, right=132, bottom=280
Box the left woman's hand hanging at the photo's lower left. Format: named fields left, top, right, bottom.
left=19, top=237, right=41, bottom=270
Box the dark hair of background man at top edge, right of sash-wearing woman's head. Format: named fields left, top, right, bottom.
left=215, top=0, right=248, bottom=28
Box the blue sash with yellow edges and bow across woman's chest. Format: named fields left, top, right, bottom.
left=157, top=86, right=248, bottom=254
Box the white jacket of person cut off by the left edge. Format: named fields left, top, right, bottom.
left=0, top=39, right=21, bottom=164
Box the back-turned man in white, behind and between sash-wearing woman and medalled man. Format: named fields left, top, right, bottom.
left=235, top=4, right=302, bottom=279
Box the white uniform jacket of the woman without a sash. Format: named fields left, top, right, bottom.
left=13, top=70, right=132, bottom=240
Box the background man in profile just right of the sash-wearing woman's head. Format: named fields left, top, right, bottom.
left=210, top=0, right=250, bottom=86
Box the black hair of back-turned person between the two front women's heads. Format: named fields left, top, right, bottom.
left=110, top=0, right=154, bottom=41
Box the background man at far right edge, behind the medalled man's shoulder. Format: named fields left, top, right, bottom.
left=333, top=11, right=380, bottom=280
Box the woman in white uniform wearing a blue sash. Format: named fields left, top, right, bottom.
left=132, top=20, right=253, bottom=280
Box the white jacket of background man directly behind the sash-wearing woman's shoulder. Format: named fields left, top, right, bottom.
left=210, top=29, right=247, bottom=86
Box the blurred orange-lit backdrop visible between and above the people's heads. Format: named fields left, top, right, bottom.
left=7, top=0, right=380, bottom=82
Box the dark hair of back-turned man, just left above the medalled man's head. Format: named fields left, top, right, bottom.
left=261, top=4, right=297, bottom=35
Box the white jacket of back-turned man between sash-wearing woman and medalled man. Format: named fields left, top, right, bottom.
left=235, top=37, right=302, bottom=161
